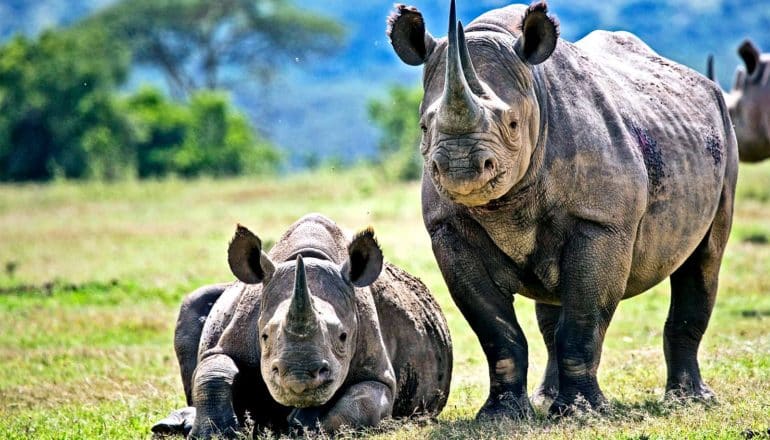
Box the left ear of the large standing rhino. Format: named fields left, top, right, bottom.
left=385, top=4, right=436, bottom=66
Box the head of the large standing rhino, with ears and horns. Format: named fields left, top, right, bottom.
left=388, top=0, right=559, bottom=206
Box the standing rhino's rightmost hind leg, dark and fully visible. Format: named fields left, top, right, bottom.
left=663, top=180, right=733, bottom=400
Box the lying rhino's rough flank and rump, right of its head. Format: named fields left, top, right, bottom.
left=371, top=263, right=452, bottom=417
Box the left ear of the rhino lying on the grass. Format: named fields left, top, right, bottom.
left=227, top=224, right=275, bottom=284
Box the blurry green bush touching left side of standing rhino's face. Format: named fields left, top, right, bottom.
left=369, top=86, right=422, bottom=180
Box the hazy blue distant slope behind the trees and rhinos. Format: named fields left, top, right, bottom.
left=0, top=0, right=770, bottom=166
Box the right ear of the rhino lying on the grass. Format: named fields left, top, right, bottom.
left=342, top=228, right=382, bottom=287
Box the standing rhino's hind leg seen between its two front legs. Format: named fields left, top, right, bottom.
left=532, top=303, right=561, bottom=406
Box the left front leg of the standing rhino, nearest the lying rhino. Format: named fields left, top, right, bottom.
left=431, top=222, right=533, bottom=418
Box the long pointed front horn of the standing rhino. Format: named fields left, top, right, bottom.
left=439, top=0, right=481, bottom=131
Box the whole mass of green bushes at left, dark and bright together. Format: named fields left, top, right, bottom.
left=0, top=29, right=280, bottom=181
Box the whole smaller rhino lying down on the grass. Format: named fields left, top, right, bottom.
left=153, top=215, right=452, bottom=438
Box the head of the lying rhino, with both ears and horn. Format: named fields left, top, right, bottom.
left=228, top=225, right=382, bottom=408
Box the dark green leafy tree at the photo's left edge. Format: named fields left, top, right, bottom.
left=0, top=29, right=133, bottom=180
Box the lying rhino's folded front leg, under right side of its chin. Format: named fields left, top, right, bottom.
left=289, top=381, right=393, bottom=432
